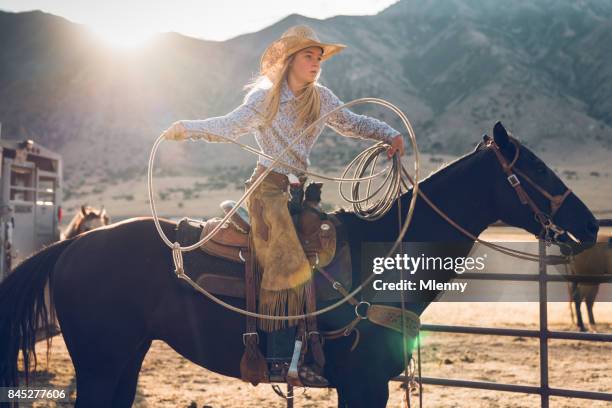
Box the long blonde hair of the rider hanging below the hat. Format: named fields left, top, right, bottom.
left=244, top=52, right=321, bottom=132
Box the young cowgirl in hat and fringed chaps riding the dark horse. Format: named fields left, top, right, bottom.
left=164, top=25, right=404, bottom=386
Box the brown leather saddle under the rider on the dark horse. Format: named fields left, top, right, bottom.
left=176, top=183, right=352, bottom=300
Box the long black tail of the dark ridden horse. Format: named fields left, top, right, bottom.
left=0, top=240, right=72, bottom=387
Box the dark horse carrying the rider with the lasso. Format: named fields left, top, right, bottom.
left=0, top=124, right=598, bottom=408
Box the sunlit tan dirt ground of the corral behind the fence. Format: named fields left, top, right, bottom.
left=17, top=303, right=612, bottom=408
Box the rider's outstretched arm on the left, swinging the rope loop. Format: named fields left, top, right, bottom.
left=170, top=90, right=264, bottom=143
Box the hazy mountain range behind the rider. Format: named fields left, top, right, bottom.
left=0, top=0, right=612, bottom=190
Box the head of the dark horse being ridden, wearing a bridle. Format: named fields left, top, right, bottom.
left=476, top=122, right=599, bottom=255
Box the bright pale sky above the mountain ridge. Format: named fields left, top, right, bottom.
left=0, top=0, right=397, bottom=45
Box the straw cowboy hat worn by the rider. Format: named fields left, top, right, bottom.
left=260, top=25, right=346, bottom=78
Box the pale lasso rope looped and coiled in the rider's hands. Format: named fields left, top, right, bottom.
left=147, top=98, right=420, bottom=320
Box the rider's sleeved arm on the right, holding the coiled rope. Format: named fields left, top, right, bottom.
left=321, top=87, right=401, bottom=144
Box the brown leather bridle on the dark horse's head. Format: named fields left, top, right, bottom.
left=484, top=135, right=580, bottom=245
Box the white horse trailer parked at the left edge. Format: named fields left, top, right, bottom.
left=0, top=128, right=62, bottom=281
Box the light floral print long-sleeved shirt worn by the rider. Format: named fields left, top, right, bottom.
left=179, top=79, right=399, bottom=175
